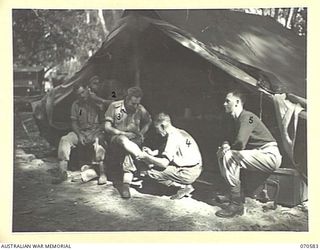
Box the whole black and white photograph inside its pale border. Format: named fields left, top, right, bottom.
left=11, top=6, right=312, bottom=233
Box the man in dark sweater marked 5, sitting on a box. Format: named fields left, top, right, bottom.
left=216, top=91, right=282, bottom=218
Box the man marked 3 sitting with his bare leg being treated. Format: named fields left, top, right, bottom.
left=105, top=87, right=152, bottom=199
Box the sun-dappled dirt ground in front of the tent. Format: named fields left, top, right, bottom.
left=13, top=114, right=308, bottom=232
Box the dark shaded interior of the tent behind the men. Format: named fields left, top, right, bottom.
left=47, top=11, right=306, bottom=179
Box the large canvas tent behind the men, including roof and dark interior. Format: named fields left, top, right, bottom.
left=33, top=10, right=306, bottom=177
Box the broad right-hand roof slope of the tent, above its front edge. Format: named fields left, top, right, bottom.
left=156, top=10, right=306, bottom=98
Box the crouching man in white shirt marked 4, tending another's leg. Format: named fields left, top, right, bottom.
left=139, top=113, right=202, bottom=199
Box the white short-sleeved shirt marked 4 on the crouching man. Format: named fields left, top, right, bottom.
left=162, top=128, right=202, bottom=167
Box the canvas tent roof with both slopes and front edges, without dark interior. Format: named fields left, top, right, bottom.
left=41, top=10, right=306, bottom=127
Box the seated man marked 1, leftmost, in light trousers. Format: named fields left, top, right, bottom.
left=58, top=85, right=107, bottom=185
